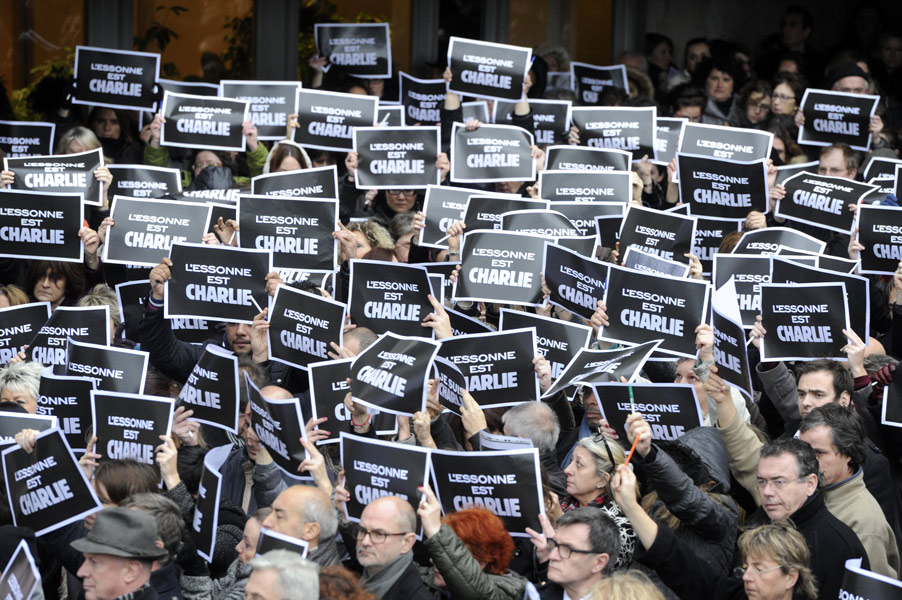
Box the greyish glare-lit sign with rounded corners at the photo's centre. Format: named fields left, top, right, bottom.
left=452, top=231, right=545, bottom=306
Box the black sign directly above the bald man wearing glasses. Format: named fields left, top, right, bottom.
left=341, top=431, right=429, bottom=523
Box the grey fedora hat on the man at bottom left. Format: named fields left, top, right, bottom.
left=72, top=507, right=169, bottom=560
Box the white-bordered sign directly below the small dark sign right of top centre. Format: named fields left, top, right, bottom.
left=572, top=106, right=657, bottom=159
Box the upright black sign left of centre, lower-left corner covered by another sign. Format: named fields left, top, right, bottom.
left=238, top=194, right=338, bottom=273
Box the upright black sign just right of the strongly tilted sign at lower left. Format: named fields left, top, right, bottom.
left=91, top=390, right=175, bottom=465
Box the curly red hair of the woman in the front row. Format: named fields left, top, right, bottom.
left=443, top=508, right=514, bottom=575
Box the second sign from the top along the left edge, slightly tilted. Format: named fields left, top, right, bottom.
left=3, top=148, right=103, bottom=206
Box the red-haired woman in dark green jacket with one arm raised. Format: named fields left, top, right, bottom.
left=417, top=487, right=526, bottom=600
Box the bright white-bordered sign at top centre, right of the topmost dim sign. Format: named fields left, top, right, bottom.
left=448, top=36, right=532, bottom=102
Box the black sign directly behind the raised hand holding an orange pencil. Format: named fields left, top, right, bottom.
left=595, top=383, right=702, bottom=441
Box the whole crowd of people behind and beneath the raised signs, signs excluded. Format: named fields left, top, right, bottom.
left=0, top=7, right=902, bottom=600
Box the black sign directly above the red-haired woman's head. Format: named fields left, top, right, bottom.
left=430, top=448, right=545, bottom=537
